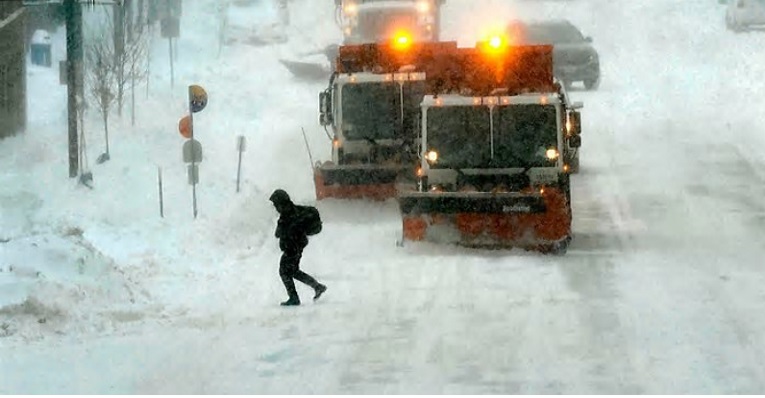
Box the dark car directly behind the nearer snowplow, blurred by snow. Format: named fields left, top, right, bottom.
left=508, top=20, right=600, bottom=90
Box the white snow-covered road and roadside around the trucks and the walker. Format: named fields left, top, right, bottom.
left=0, top=0, right=765, bottom=394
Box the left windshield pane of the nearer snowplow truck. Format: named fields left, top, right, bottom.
left=425, top=106, right=491, bottom=169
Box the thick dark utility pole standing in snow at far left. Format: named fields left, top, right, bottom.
left=64, top=0, right=84, bottom=178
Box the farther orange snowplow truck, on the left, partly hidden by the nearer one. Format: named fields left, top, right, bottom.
left=314, top=35, right=457, bottom=200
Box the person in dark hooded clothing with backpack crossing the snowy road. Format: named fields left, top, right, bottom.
left=270, top=189, right=327, bottom=305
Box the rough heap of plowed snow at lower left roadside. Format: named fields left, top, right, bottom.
left=0, top=232, right=148, bottom=340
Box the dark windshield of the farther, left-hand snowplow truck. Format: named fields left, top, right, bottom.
left=342, top=81, right=425, bottom=140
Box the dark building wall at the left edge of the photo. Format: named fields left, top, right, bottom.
left=0, top=0, right=27, bottom=138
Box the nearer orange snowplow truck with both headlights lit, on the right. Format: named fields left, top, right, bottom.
left=398, top=40, right=581, bottom=253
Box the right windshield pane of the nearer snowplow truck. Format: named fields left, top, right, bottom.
left=491, top=104, right=558, bottom=168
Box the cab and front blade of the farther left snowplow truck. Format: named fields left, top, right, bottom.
left=315, top=71, right=425, bottom=199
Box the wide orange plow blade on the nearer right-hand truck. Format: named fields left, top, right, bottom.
left=398, top=188, right=571, bottom=254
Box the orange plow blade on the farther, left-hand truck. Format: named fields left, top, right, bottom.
left=313, top=166, right=405, bottom=200
